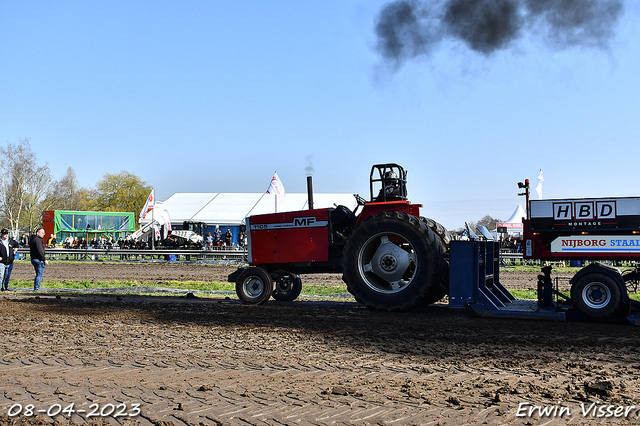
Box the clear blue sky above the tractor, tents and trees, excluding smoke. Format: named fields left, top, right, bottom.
left=0, top=0, right=640, bottom=228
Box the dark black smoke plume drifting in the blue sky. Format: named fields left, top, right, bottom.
left=375, top=0, right=624, bottom=65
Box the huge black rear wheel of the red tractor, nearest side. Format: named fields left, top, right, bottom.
left=342, top=212, right=443, bottom=311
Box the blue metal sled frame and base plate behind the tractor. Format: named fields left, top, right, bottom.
left=449, top=240, right=640, bottom=325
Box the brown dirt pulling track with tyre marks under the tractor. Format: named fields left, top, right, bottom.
left=0, top=264, right=640, bottom=425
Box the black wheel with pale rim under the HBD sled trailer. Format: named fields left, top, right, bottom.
left=571, top=273, right=621, bottom=318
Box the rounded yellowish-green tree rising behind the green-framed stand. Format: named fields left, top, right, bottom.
left=91, top=171, right=151, bottom=218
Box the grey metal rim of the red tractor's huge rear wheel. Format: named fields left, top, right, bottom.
left=358, top=232, right=418, bottom=294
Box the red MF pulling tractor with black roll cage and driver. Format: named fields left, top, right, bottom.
left=229, top=163, right=450, bottom=311
